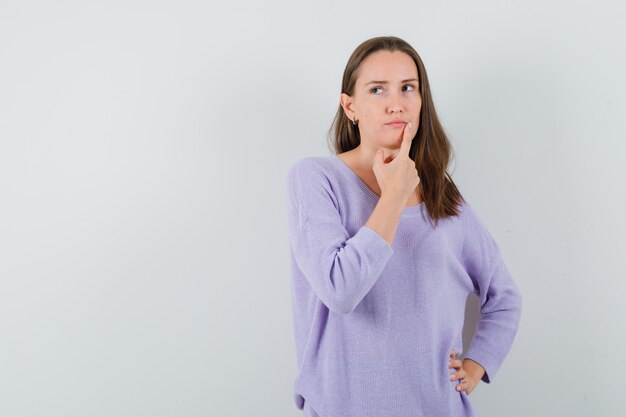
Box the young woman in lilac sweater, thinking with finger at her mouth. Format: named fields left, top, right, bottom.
left=286, top=36, right=522, bottom=417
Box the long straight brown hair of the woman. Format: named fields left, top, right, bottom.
left=329, top=36, right=465, bottom=226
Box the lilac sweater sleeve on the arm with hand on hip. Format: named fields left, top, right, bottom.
left=463, top=203, right=522, bottom=383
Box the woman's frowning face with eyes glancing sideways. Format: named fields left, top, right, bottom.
left=340, top=51, right=422, bottom=149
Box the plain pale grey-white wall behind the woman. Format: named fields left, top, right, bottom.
left=0, top=0, right=626, bottom=417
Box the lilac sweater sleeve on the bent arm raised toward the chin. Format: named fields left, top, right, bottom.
left=286, top=158, right=393, bottom=314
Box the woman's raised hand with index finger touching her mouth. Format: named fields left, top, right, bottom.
left=372, top=123, right=420, bottom=207
